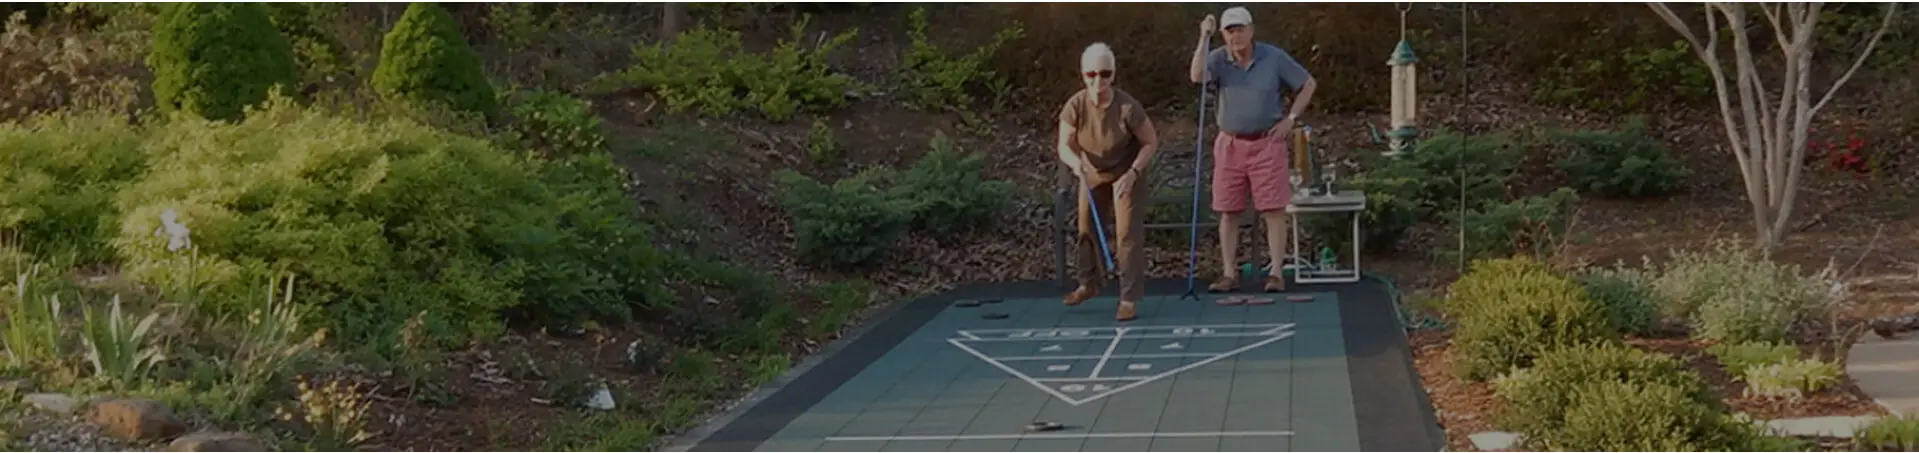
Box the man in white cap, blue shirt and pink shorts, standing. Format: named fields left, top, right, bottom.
left=1192, top=8, right=1316, bottom=292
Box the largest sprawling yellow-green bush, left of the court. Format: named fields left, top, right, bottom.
left=115, top=98, right=658, bottom=342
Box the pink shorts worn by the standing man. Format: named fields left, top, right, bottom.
left=1213, top=132, right=1293, bottom=213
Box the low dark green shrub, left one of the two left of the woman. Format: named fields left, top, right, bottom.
left=777, top=169, right=913, bottom=265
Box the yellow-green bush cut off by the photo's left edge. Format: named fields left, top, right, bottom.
left=0, top=113, right=146, bottom=262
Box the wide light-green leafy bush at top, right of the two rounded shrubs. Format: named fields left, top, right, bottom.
left=606, top=19, right=860, bottom=121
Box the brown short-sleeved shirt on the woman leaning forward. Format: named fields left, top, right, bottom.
left=1059, top=88, right=1148, bottom=173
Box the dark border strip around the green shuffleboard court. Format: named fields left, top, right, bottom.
left=666, top=278, right=1445, bottom=451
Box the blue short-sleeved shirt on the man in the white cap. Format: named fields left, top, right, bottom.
left=1205, top=42, right=1313, bottom=134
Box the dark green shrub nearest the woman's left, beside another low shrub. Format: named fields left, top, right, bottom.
left=890, top=131, right=1013, bottom=234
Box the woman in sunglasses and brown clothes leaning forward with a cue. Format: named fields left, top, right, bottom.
left=1059, top=42, right=1159, bottom=321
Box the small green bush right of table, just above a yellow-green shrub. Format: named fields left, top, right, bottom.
left=1433, top=188, right=1579, bottom=259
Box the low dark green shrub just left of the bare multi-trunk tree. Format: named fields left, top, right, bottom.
left=1552, top=117, right=1689, bottom=198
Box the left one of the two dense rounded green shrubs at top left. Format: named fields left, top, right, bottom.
left=148, top=2, right=299, bottom=119
